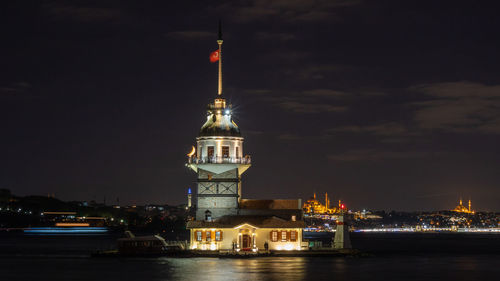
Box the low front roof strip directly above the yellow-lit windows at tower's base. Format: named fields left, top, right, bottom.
left=187, top=216, right=305, bottom=228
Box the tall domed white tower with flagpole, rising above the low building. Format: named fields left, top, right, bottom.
left=187, top=23, right=251, bottom=221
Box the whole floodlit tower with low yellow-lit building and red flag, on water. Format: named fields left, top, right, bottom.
left=186, top=25, right=307, bottom=252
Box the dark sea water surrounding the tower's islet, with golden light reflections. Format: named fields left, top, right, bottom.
left=0, top=233, right=500, bottom=281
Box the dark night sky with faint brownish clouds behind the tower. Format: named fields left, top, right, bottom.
left=0, top=0, right=500, bottom=211
